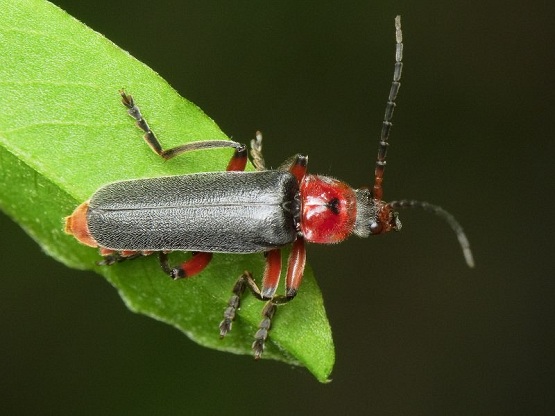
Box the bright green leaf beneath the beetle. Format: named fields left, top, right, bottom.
left=0, top=0, right=334, bottom=381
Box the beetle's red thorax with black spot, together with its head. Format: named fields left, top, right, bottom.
left=300, top=175, right=401, bottom=244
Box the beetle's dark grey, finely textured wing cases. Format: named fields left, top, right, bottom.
left=87, top=171, right=299, bottom=253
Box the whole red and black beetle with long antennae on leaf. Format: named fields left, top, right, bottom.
left=65, top=16, right=474, bottom=358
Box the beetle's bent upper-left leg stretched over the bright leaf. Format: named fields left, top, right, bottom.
left=119, top=90, right=246, bottom=166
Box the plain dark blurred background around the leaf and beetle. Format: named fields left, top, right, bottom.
left=0, top=0, right=555, bottom=415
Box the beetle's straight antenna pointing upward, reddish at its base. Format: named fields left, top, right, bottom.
left=372, top=16, right=403, bottom=201
